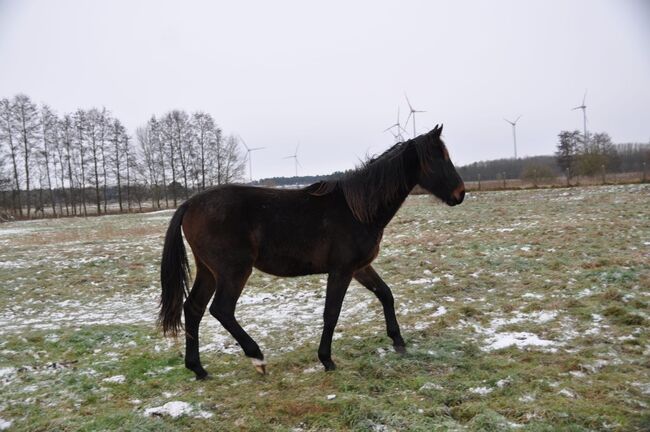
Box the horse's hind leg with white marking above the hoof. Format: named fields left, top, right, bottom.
left=210, top=267, right=266, bottom=374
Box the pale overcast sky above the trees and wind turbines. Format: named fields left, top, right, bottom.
left=0, top=0, right=650, bottom=178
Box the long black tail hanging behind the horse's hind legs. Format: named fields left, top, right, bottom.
left=158, top=202, right=190, bottom=336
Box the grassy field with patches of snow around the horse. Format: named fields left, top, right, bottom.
left=0, top=185, right=650, bottom=431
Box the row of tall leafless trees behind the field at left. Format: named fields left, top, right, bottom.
left=0, top=94, right=244, bottom=217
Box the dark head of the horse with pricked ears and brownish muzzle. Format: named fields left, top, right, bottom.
left=415, top=125, right=465, bottom=206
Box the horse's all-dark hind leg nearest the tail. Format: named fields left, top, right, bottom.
left=183, top=259, right=215, bottom=379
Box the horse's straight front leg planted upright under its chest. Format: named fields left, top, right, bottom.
left=318, top=272, right=352, bottom=371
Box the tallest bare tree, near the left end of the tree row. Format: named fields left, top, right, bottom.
left=13, top=94, right=40, bottom=217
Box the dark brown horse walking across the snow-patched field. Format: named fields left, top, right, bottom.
left=159, top=126, right=465, bottom=379
